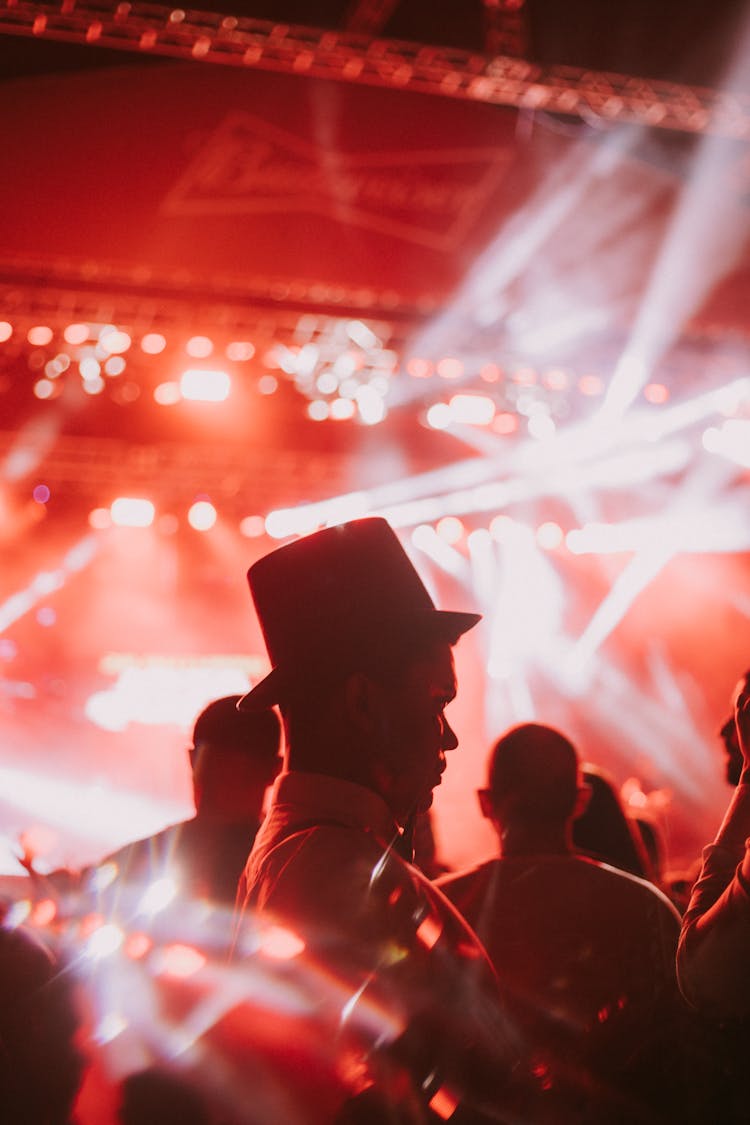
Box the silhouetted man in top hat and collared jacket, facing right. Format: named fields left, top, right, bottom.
left=240, top=519, right=521, bottom=1122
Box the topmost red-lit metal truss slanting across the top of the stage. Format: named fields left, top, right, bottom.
left=0, top=0, right=750, bottom=140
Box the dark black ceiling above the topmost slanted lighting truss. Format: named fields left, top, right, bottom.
left=0, top=0, right=747, bottom=86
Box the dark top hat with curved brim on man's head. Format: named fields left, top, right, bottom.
left=237, top=518, right=480, bottom=711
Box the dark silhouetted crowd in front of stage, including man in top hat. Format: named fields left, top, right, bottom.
left=0, top=519, right=750, bottom=1125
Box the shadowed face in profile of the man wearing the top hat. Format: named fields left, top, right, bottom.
left=380, top=642, right=459, bottom=822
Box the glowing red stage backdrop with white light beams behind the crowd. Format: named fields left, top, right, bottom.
left=0, top=6, right=750, bottom=886
